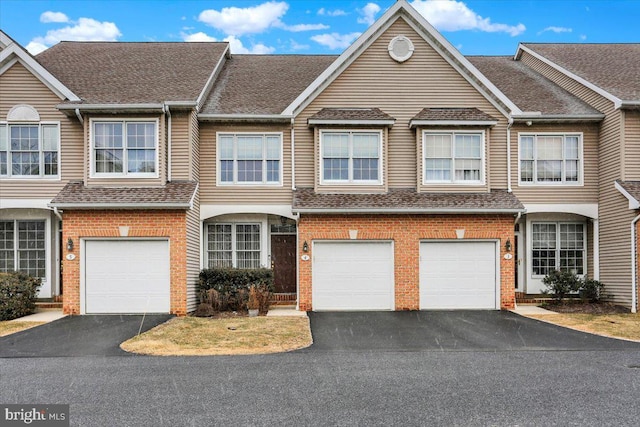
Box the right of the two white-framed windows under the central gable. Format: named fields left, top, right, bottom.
left=423, top=132, right=484, bottom=184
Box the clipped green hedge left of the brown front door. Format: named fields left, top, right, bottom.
left=199, top=268, right=273, bottom=313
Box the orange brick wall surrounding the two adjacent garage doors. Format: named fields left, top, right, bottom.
left=298, top=215, right=515, bottom=311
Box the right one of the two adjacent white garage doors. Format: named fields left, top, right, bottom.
left=420, top=241, right=499, bottom=309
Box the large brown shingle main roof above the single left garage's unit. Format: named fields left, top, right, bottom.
left=36, top=42, right=227, bottom=104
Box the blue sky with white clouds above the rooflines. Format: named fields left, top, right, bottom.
left=0, top=0, right=640, bottom=55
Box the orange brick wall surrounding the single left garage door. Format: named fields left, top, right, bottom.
left=62, top=210, right=187, bottom=316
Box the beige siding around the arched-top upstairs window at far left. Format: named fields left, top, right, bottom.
left=0, top=62, right=83, bottom=199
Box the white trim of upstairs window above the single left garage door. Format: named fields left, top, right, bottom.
left=89, top=117, right=160, bottom=179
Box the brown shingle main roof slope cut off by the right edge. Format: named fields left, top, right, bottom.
left=523, top=43, right=640, bottom=101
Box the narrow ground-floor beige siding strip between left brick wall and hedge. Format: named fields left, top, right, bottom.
left=186, top=191, right=202, bottom=312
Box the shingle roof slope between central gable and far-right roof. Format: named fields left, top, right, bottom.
left=467, top=56, right=599, bottom=115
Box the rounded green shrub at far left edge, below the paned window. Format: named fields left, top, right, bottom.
left=0, top=271, right=41, bottom=320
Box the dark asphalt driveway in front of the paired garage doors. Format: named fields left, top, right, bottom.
left=300, top=310, right=640, bottom=352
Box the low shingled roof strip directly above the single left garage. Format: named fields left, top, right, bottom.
left=50, top=181, right=198, bottom=209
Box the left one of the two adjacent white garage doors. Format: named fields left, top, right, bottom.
left=312, top=242, right=394, bottom=310
